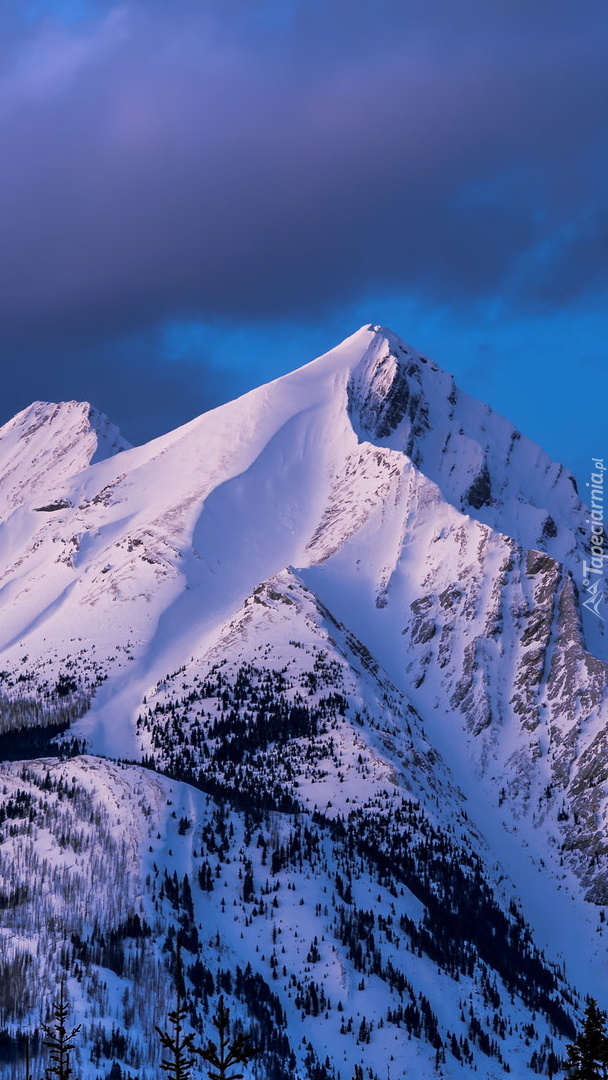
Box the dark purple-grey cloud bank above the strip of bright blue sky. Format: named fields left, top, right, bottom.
left=0, top=0, right=608, bottom=436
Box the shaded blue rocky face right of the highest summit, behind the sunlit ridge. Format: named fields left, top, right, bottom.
left=329, top=324, right=582, bottom=562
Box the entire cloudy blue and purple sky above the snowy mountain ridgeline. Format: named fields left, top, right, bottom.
left=0, top=0, right=608, bottom=484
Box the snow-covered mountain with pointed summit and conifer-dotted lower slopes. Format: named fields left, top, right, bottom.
left=0, top=327, right=608, bottom=1080
